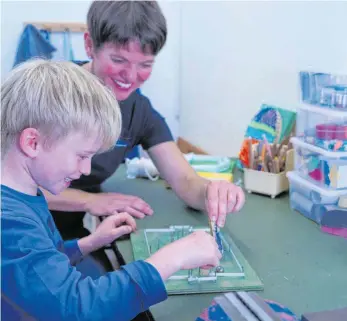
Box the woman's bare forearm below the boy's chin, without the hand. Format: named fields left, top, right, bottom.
left=41, top=188, right=90, bottom=212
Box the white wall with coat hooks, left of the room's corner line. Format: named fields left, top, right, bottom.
left=1, top=0, right=180, bottom=137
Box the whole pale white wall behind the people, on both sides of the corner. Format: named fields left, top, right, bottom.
left=1, top=0, right=347, bottom=156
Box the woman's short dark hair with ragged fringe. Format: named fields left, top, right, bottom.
left=87, top=1, right=167, bottom=55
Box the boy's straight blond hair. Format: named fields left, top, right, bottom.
left=1, top=59, right=121, bottom=158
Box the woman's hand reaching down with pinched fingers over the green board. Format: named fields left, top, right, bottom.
left=205, top=181, right=245, bottom=227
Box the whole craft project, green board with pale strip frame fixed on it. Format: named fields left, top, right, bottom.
left=131, top=225, right=263, bottom=294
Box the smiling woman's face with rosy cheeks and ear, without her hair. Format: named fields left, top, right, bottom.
left=85, top=34, right=155, bottom=101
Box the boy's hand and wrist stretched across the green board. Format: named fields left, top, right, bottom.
left=146, top=231, right=222, bottom=280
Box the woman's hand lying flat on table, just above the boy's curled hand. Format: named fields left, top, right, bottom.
left=86, top=193, right=153, bottom=218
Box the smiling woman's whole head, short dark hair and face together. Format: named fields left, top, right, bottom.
left=85, top=1, right=167, bottom=101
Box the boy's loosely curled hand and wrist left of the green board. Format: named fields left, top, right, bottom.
left=78, top=213, right=136, bottom=255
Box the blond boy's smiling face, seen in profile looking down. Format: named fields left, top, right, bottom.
left=30, top=132, right=100, bottom=194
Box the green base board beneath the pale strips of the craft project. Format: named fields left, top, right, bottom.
left=131, top=227, right=264, bottom=294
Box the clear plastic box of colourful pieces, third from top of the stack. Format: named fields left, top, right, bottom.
left=290, top=137, right=347, bottom=189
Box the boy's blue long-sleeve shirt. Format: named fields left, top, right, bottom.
left=1, top=185, right=167, bottom=321
